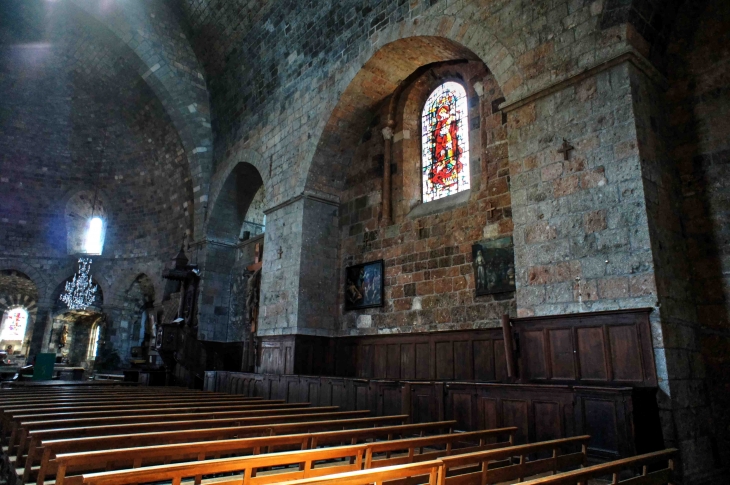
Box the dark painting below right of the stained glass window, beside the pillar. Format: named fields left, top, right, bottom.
left=471, top=237, right=515, bottom=295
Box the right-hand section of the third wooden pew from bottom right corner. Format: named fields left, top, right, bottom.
left=365, top=427, right=517, bottom=468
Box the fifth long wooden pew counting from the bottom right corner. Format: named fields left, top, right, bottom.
left=23, top=415, right=406, bottom=483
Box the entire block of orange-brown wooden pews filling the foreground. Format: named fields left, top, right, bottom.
left=0, top=385, right=675, bottom=485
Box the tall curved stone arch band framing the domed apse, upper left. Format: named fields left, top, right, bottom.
left=63, top=0, right=213, bottom=238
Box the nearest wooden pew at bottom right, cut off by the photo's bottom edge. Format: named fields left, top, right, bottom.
left=523, top=448, right=677, bottom=485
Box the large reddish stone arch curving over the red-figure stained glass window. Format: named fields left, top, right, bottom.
left=300, top=32, right=522, bottom=197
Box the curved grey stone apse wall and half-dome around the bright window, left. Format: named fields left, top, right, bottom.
left=0, top=2, right=193, bottom=360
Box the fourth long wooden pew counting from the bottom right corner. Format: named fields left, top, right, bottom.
left=38, top=421, right=456, bottom=485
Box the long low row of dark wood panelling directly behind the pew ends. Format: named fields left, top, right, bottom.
left=206, top=371, right=663, bottom=458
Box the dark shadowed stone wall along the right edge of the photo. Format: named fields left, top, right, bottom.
left=666, top=1, right=730, bottom=470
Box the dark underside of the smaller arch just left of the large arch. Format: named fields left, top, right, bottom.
left=206, top=162, right=264, bottom=244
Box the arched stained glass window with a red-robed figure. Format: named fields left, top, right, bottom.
left=421, top=81, right=470, bottom=202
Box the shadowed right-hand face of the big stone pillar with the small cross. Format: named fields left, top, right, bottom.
left=629, top=66, right=719, bottom=483
